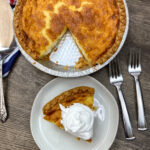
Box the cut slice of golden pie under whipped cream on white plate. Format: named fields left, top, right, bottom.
left=43, top=86, right=94, bottom=129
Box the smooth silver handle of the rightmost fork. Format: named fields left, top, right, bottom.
left=134, top=76, right=147, bottom=131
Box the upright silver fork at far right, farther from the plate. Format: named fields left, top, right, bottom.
left=128, top=51, right=147, bottom=131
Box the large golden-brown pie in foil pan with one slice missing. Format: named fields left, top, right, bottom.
left=14, top=0, right=126, bottom=66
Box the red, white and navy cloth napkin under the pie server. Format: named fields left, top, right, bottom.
left=3, top=0, right=20, bottom=77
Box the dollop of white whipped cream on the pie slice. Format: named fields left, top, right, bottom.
left=59, top=103, right=94, bottom=140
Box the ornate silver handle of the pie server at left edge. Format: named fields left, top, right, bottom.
left=0, top=59, right=7, bottom=122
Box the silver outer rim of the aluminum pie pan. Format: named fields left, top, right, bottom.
left=15, top=0, right=129, bottom=77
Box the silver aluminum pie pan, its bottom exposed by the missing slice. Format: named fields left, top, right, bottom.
left=15, top=0, right=129, bottom=77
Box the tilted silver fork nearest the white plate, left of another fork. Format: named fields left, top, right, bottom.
left=109, top=59, right=135, bottom=140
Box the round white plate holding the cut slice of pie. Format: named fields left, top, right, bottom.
left=30, top=76, right=119, bottom=150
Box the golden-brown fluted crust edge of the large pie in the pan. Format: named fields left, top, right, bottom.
left=14, top=0, right=126, bottom=66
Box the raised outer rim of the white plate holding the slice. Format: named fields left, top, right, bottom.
left=30, top=76, right=119, bottom=150
